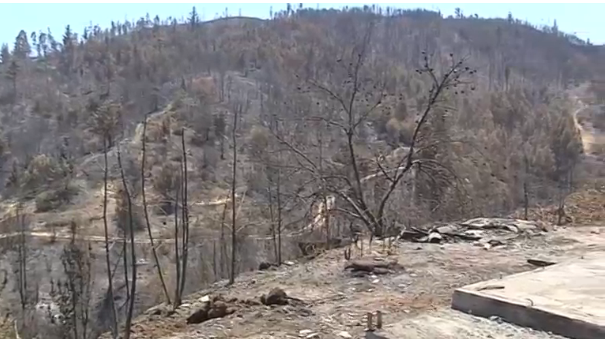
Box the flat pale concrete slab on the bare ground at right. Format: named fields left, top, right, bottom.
left=452, top=252, right=605, bottom=339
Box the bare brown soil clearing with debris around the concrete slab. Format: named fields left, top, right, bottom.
left=117, top=227, right=605, bottom=339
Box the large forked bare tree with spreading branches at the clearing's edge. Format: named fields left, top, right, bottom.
left=274, top=23, right=475, bottom=237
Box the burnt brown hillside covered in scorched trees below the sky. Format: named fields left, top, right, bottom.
left=0, top=7, right=605, bottom=338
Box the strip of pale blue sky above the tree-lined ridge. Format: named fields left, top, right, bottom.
left=0, top=3, right=605, bottom=47
